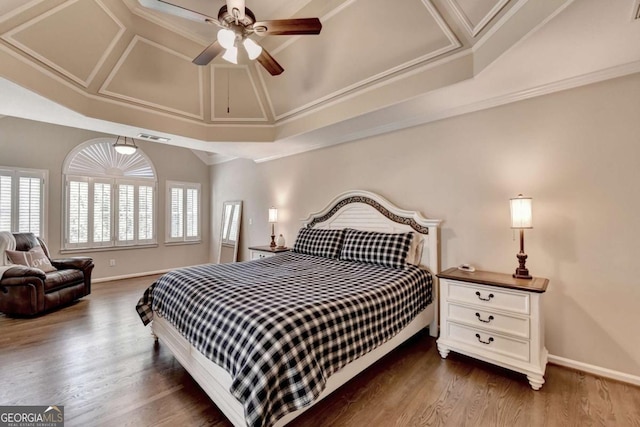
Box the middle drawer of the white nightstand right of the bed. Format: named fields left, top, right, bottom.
left=446, top=303, right=530, bottom=339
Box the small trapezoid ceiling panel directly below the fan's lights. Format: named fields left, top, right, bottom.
left=211, top=65, right=267, bottom=122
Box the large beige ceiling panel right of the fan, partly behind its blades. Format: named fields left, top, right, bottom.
left=261, top=0, right=460, bottom=119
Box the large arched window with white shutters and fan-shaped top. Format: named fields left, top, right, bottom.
left=63, top=138, right=157, bottom=249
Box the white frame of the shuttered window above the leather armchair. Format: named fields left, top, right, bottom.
left=0, top=166, right=49, bottom=242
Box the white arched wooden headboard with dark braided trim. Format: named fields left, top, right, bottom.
left=303, top=190, right=442, bottom=275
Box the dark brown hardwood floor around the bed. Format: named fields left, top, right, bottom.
left=0, top=276, right=640, bottom=427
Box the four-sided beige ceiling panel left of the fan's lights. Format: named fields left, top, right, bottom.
left=100, top=36, right=204, bottom=119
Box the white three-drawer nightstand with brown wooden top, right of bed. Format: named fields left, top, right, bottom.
left=438, top=268, right=549, bottom=390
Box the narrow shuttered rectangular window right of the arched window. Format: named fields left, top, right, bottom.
left=166, top=181, right=201, bottom=242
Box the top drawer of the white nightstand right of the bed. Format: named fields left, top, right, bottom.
left=448, top=281, right=529, bottom=314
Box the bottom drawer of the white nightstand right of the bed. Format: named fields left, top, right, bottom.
left=447, top=322, right=529, bottom=362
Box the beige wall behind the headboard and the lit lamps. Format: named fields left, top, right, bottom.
left=211, top=74, right=640, bottom=376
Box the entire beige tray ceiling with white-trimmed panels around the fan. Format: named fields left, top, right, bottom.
left=0, top=0, right=620, bottom=161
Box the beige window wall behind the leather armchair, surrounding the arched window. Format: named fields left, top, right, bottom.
left=0, top=117, right=210, bottom=278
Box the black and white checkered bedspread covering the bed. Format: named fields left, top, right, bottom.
left=136, top=252, right=432, bottom=426
